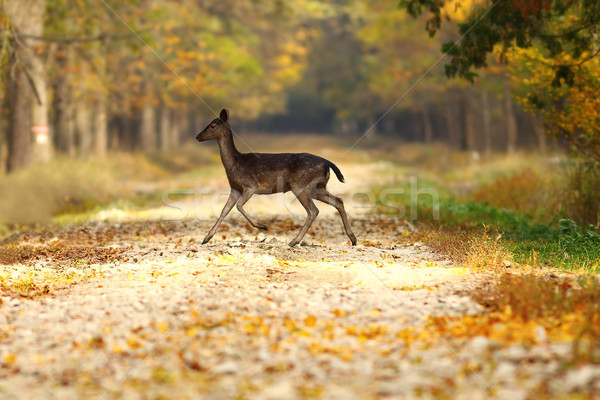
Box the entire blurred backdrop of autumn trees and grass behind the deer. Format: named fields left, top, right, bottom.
left=0, top=0, right=600, bottom=241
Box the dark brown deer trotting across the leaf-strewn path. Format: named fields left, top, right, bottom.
left=196, top=109, right=356, bottom=247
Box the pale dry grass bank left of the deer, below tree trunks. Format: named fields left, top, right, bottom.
left=0, top=146, right=216, bottom=227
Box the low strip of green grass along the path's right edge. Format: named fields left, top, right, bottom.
left=379, top=188, right=600, bottom=272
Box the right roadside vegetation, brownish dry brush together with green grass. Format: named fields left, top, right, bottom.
left=370, top=143, right=600, bottom=272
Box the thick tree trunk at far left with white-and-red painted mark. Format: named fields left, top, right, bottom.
left=4, top=0, right=52, bottom=172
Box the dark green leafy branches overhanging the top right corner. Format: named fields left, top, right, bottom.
left=400, top=0, right=600, bottom=84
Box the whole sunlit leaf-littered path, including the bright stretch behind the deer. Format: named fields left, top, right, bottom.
left=0, top=145, right=600, bottom=400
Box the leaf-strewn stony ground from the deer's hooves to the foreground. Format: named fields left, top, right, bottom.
left=0, top=208, right=600, bottom=400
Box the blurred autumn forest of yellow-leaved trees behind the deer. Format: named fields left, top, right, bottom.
left=0, top=0, right=598, bottom=168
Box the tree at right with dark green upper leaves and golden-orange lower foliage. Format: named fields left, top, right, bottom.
left=400, top=0, right=600, bottom=159
